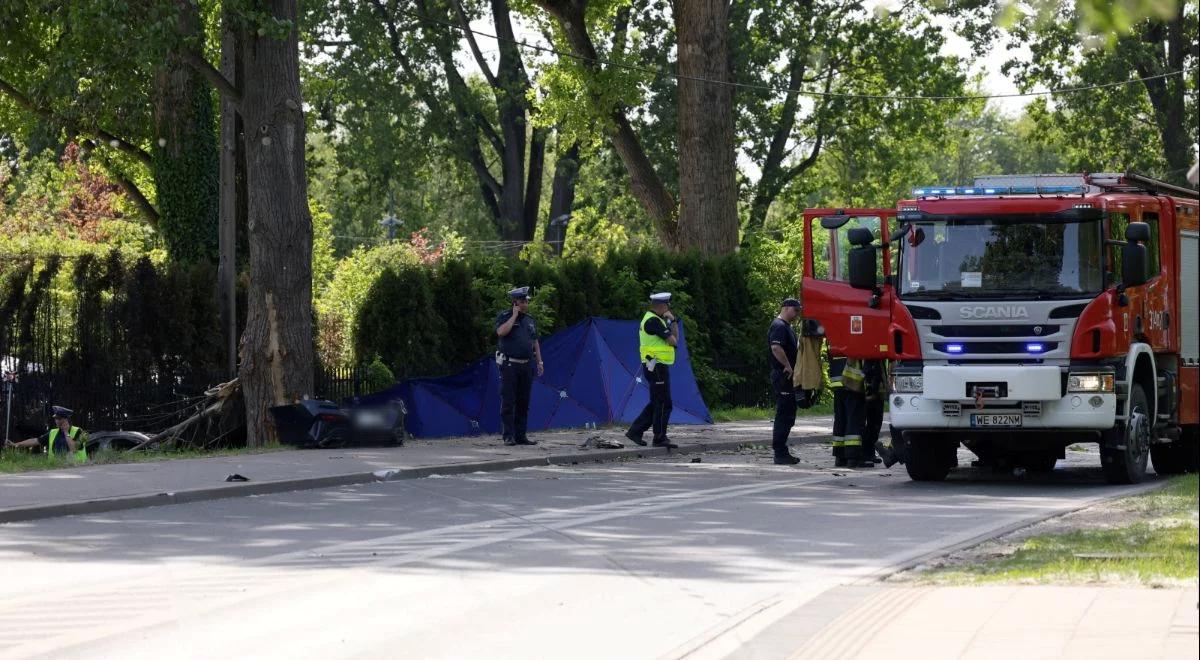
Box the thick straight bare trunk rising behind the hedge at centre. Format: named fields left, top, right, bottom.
left=674, top=0, right=738, bottom=254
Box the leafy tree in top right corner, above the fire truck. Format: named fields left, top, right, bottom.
left=947, top=0, right=1200, bottom=184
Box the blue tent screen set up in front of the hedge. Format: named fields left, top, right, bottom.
left=353, top=318, right=713, bottom=438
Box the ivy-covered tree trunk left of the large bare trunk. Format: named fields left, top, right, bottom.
left=152, top=0, right=220, bottom=262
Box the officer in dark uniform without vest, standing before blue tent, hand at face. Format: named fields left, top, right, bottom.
left=496, top=287, right=545, bottom=445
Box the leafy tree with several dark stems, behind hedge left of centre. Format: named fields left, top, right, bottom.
left=307, top=0, right=548, bottom=241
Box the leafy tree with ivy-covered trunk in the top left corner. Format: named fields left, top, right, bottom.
left=0, top=0, right=217, bottom=260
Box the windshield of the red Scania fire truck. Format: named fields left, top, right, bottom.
left=899, top=216, right=1104, bottom=299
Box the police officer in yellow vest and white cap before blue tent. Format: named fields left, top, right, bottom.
left=625, top=293, right=679, bottom=449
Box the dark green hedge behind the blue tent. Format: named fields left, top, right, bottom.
left=353, top=248, right=794, bottom=402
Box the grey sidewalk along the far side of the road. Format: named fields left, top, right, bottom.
left=0, top=416, right=833, bottom=523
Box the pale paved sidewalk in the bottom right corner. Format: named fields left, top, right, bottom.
left=727, top=586, right=1200, bottom=660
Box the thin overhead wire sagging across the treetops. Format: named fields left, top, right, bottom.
left=397, top=10, right=1196, bottom=101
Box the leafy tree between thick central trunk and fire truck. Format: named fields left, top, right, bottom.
left=733, top=0, right=964, bottom=232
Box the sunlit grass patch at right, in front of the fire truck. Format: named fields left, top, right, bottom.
left=920, top=474, right=1200, bottom=586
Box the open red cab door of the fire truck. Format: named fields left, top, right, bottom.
left=802, top=209, right=896, bottom=360
